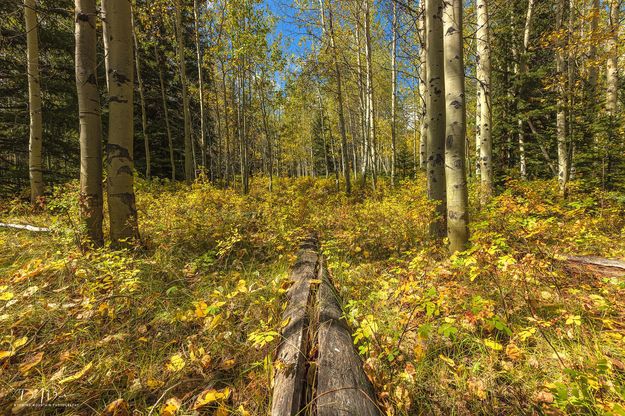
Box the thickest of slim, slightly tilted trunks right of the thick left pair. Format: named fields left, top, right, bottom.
left=175, top=0, right=195, bottom=183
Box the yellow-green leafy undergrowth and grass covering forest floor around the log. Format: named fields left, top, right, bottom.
left=0, top=178, right=625, bottom=416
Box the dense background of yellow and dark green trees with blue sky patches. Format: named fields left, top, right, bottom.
left=0, top=1, right=625, bottom=194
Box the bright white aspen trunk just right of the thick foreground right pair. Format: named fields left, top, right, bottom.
left=476, top=0, right=492, bottom=204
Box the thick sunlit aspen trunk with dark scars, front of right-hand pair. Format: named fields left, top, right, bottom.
left=443, top=0, right=469, bottom=253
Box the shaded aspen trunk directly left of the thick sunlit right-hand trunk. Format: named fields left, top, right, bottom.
left=425, top=0, right=447, bottom=237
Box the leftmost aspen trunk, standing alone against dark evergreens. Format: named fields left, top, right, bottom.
left=24, top=0, right=43, bottom=203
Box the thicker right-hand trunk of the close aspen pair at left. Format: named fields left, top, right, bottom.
left=102, top=0, right=139, bottom=245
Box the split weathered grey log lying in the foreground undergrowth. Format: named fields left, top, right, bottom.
left=271, top=237, right=382, bottom=416
